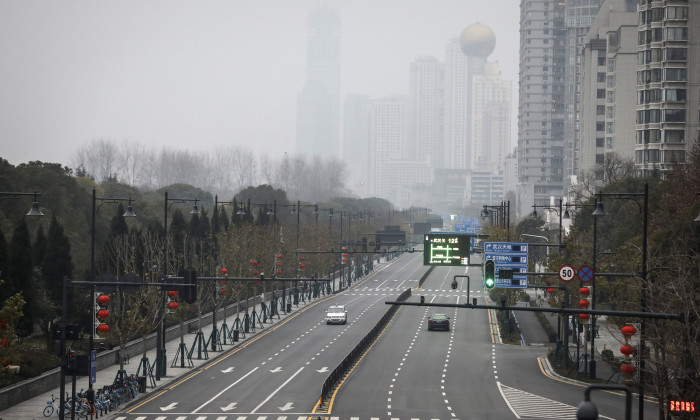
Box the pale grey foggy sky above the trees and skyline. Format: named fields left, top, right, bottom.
left=0, top=0, right=520, bottom=165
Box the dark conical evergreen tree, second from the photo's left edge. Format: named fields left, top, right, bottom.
left=41, top=216, right=73, bottom=303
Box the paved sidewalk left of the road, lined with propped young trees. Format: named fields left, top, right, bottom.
left=0, top=282, right=338, bottom=420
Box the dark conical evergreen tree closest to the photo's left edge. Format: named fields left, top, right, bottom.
left=7, top=218, right=34, bottom=336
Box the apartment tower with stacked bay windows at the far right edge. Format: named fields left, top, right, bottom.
left=635, top=0, right=700, bottom=176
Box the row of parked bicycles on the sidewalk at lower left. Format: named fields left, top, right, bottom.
left=44, top=375, right=139, bottom=418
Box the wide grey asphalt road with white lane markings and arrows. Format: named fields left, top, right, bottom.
left=110, top=253, right=656, bottom=420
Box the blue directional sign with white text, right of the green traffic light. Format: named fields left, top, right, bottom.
left=484, top=242, right=528, bottom=289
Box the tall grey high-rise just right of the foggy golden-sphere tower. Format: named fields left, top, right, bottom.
left=516, top=0, right=566, bottom=215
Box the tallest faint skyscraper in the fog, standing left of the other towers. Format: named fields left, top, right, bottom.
left=296, top=6, right=340, bottom=158
